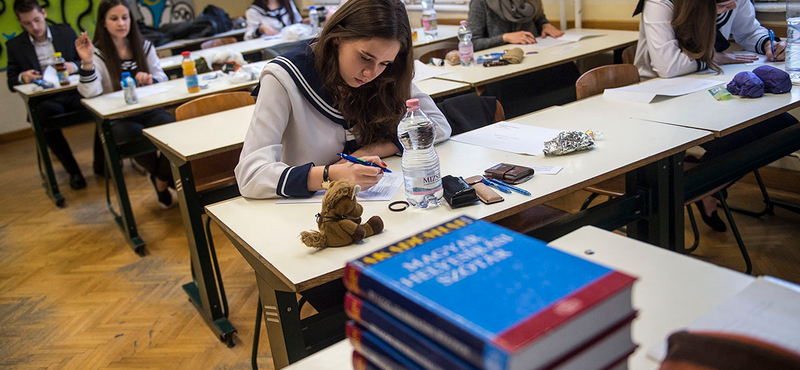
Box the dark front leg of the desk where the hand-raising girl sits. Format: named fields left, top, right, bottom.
left=96, top=118, right=145, bottom=255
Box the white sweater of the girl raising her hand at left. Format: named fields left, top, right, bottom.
left=78, top=40, right=169, bottom=98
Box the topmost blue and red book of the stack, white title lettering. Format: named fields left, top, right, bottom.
left=344, top=216, right=635, bottom=370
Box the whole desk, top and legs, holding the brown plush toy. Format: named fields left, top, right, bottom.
left=206, top=108, right=711, bottom=368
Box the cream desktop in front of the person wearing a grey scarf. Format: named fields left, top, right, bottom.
left=437, top=29, right=639, bottom=88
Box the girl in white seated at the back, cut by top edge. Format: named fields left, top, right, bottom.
left=244, top=0, right=303, bottom=40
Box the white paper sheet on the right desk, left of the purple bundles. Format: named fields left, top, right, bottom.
left=603, top=77, right=724, bottom=103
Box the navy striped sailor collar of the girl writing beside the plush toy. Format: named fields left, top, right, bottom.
left=270, top=40, right=348, bottom=129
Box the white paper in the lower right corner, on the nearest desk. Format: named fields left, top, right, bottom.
left=647, top=276, right=800, bottom=362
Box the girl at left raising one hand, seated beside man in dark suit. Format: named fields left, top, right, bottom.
left=75, top=0, right=175, bottom=208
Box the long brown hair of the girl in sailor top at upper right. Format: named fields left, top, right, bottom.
left=672, top=0, right=722, bottom=73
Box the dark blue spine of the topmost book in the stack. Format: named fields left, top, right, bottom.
left=344, top=262, right=508, bottom=369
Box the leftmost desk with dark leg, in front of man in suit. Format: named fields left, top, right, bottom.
left=14, top=74, right=91, bottom=208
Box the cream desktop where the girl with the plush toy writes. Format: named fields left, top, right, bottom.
left=207, top=108, right=711, bottom=291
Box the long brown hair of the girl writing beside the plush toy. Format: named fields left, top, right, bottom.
left=314, top=0, right=414, bottom=145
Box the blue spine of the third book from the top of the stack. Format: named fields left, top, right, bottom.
left=345, top=321, right=423, bottom=370
